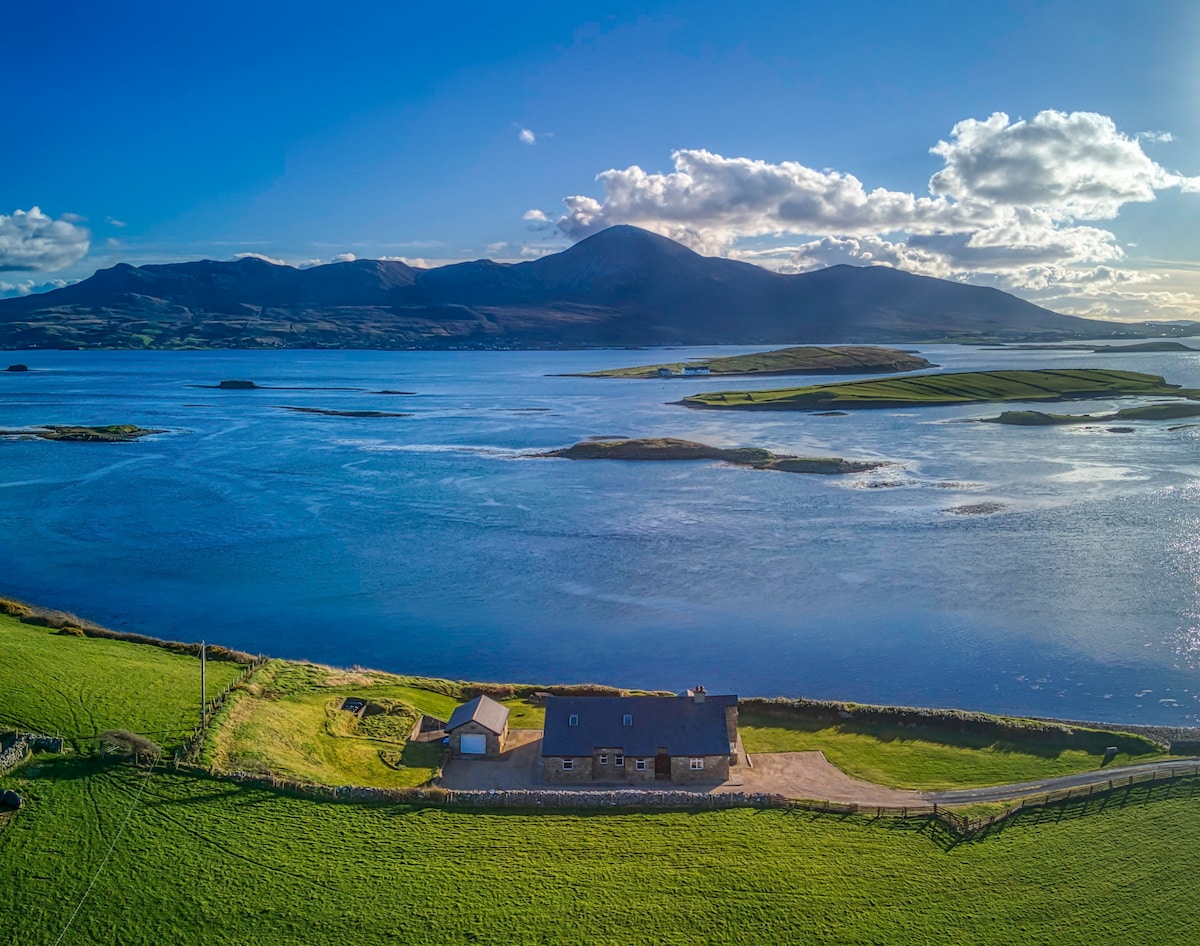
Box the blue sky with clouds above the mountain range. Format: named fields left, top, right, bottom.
left=0, top=0, right=1200, bottom=318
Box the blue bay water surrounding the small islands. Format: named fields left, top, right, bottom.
left=0, top=346, right=1200, bottom=724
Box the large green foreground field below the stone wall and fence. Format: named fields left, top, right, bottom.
left=0, top=760, right=1200, bottom=946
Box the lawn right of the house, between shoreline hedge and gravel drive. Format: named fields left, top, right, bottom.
left=739, top=708, right=1160, bottom=790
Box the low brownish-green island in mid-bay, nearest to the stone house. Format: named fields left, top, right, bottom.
left=536, top=437, right=892, bottom=474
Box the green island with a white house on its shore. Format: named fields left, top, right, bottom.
left=563, top=345, right=937, bottom=378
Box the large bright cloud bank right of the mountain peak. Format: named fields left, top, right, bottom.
left=549, top=110, right=1200, bottom=318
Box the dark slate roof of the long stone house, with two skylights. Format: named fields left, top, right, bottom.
left=541, top=696, right=737, bottom=756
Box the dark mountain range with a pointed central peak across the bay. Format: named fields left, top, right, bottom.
left=0, top=227, right=1136, bottom=348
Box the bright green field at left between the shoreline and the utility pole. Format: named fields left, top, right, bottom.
left=0, top=615, right=241, bottom=748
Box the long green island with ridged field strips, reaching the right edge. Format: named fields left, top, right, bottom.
left=678, top=369, right=1200, bottom=411
